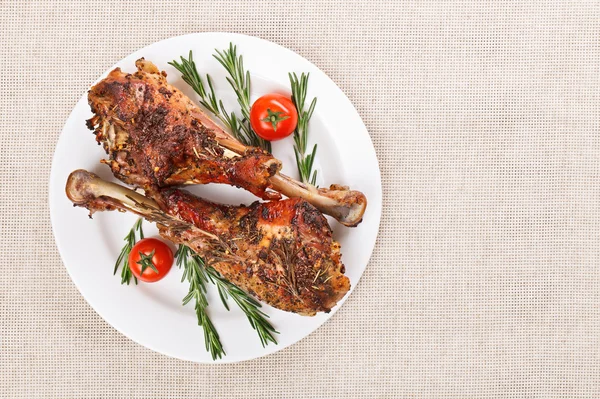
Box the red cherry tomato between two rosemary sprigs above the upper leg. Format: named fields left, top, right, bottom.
left=250, top=94, right=298, bottom=141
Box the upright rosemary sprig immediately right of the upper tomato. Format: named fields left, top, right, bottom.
left=288, top=73, right=317, bottom=185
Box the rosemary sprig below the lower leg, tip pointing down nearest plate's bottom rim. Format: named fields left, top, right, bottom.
left=175, top=245, right=225, bottom=360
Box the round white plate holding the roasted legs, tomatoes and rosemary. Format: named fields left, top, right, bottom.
left=50, top=33, right=382, bottom=363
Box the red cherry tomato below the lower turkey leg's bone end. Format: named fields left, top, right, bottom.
left=129, top=238, right=173, bottom=283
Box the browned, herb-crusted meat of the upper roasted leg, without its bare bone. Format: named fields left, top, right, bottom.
left=88, top=59, right=281, bottom=199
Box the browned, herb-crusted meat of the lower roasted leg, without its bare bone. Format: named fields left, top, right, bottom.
left=160, top=190, right=350, bottom=315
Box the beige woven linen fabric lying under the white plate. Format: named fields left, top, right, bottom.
left=0, top=0, right=600, bottom=399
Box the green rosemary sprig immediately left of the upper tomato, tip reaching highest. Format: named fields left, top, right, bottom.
left=213, top=43, right=271, bottom=152
